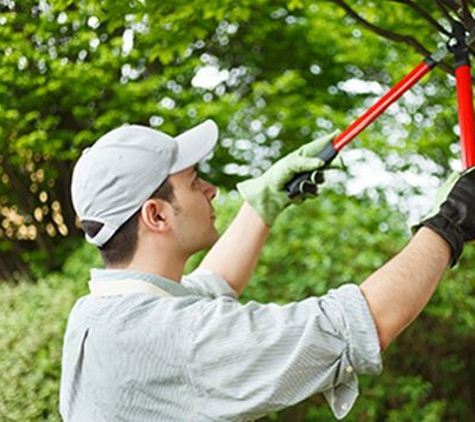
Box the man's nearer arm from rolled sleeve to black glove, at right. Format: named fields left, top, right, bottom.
left=361, top=169, right=475, bottom=349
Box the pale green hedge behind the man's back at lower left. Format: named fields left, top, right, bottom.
left=0, top=268, right=84, bottom=422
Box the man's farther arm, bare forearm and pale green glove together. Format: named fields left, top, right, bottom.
left=200, top=133, right=336, bottom=295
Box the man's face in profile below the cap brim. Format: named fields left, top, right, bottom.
left=170, top=167, right=218, bottom=255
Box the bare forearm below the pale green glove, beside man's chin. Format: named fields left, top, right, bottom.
left=200, top=203, right=270, bottom=295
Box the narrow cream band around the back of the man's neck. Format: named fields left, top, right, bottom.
left=91, top=268, right=193, bottom=296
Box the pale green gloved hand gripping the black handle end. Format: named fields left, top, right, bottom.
left=237, top=132, right=339, bottom=226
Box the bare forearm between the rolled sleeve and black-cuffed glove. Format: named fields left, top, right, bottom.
left=361, top=228, right=450, bottom=349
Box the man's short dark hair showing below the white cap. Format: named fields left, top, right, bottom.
left=81, top=179, right=175, bottom=267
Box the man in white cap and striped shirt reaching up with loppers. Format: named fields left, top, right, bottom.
left=60, top=121, right=475, bottom=422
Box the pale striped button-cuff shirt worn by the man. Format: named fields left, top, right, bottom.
left=60, top=270, right=382, bottom=422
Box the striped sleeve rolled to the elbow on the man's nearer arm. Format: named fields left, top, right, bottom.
left=188, top=285, right=382, bottom=421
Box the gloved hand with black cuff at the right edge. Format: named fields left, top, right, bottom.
left=415, top=167, right=475, bottom=267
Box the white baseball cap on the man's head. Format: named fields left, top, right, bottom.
left=71, top=120, right=218, bottom=247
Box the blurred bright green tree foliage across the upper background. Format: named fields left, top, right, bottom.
left=0, top=0, right=468, bottom=279
